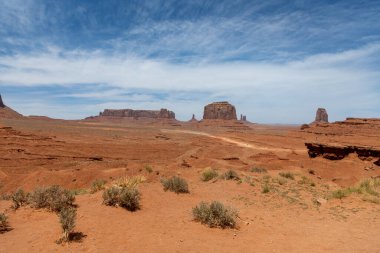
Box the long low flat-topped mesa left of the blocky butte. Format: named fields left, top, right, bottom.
left=99, top=109, right=175, bottom=119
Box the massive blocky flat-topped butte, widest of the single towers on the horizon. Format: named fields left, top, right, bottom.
left=203, top=102, right=237, bottom=120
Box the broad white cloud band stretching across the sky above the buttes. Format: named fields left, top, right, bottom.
left=0, top=44, right=380, bottom=123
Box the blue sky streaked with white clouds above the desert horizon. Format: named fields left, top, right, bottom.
left=0, top=0, right=380, bottom=123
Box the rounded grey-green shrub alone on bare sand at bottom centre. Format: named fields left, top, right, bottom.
left=193, top=201, right=238, bottom=228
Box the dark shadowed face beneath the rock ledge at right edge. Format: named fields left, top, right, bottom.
left=305, top=143, right=380, bottom=166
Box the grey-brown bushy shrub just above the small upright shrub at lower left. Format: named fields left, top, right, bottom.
left=29, top=185, right=75, bottom=212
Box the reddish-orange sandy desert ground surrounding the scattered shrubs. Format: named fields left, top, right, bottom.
left=0, top=117, right=380, bottom=253
